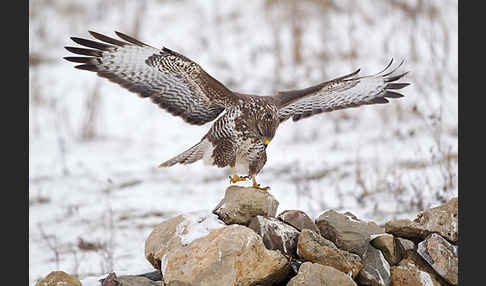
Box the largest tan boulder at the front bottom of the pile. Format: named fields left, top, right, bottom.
left=161, top=225, right=290, bottom=286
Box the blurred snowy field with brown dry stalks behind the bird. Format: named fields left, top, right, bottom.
left=29, top=0, right=458, bottom=285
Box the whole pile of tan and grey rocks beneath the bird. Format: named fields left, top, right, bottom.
left=36, top=186, right=459, bottom=286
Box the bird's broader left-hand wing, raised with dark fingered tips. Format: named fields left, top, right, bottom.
left=64, top=31, right=236, bottom=125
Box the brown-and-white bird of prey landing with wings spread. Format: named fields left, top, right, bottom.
left=64, top=31, right=409, bottom=190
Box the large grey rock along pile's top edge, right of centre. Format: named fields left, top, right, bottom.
left=316, top=210, right=385, bottom=257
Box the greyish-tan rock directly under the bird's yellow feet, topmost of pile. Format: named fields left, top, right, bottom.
left=213, top=186, right=278, bottom=225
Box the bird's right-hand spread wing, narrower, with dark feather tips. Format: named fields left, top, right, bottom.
left=272, top=60, right=409, bottom=122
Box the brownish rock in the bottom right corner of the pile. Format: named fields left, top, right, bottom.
left=417, top=233, right=459, bottom=285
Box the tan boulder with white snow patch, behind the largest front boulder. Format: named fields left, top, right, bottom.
left=145, top=211, right=226, bottom=270
